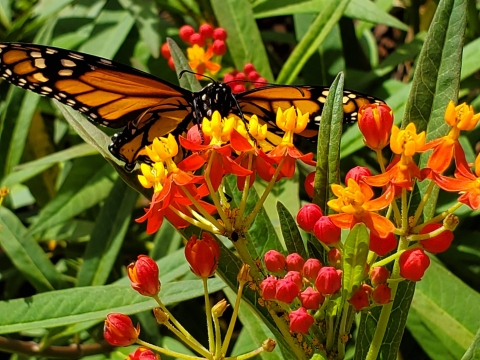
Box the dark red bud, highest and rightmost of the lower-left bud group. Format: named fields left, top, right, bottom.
left=185, top=232, right=220, bottom=278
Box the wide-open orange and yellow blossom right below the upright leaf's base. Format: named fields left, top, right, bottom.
left=327, top=178, right=395, bottom=238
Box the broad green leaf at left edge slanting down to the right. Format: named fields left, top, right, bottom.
left=0, top=207, right=64, bottom=292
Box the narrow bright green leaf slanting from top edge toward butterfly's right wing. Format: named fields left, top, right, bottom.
left=276, top=0, right=350, bottom=84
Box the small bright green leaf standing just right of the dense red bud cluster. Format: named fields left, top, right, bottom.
left=342, top=223, right=370, bottom=299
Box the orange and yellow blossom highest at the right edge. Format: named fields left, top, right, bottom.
left=424, top=101, right=480, bottom=173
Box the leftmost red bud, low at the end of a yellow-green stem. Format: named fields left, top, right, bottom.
left=103, top=313, right=140, bottom=346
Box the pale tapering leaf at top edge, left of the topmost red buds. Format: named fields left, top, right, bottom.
left=119, top=0, right=160, bottom=58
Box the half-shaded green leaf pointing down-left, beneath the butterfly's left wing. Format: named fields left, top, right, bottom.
left=29, top=156, right=114, bottom=234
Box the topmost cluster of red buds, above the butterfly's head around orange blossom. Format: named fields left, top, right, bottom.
left=161, top=24, right=227, bottom=70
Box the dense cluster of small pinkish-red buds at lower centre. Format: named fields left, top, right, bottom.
left=260, top=250, right=342, bottom=334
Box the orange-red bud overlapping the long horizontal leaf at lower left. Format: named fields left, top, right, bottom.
left=127, top=255, right=160, bottom=296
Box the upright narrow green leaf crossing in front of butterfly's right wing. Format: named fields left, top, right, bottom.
left=313, top=73, right=344, bottom=214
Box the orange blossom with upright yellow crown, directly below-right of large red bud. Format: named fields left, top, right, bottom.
left=363, top=123, right=425, bottom=190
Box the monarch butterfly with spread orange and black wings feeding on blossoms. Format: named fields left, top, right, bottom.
left=0, top=43, right=382, bottom=171
